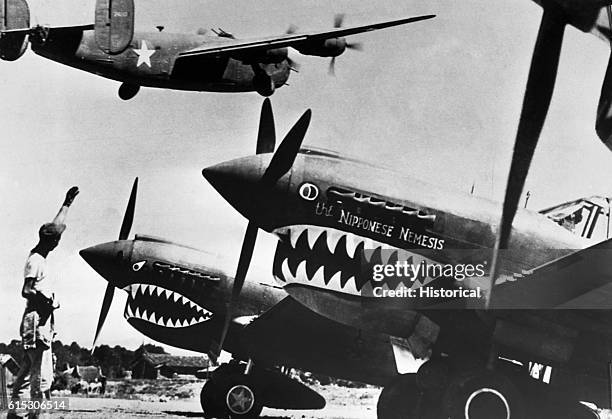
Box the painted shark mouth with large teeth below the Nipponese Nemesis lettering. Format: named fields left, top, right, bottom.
left=272, top=225, right=436, bottom=297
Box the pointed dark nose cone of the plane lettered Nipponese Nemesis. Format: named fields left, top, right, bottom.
left=202, top=154, right=272, bottom=219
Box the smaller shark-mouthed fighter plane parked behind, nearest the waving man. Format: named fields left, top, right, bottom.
left=80, top=109, right=414, bottom=418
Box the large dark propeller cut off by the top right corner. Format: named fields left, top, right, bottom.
left=487, top=0, right=612, bottom=307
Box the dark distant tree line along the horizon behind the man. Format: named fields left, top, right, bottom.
left=0, top=339, right=166, bottom=379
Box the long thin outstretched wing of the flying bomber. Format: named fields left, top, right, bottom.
left=177, top=15, right=435, bottom=60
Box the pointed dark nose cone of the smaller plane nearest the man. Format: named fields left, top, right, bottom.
left=79, top=241, right=128, bottom=284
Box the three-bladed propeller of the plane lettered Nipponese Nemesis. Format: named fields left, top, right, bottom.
left=212, top=98, right=311, bottom=356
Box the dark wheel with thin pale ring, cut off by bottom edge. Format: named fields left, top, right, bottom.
left=444, top=371, right=524, bottom=419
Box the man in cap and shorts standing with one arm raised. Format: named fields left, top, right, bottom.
left=8, top=186, right=79, bottom=418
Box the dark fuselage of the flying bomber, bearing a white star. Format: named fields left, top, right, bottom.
left=30, top=27, right=290, bottom=92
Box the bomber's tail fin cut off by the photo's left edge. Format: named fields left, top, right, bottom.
left=0, top=0, right=30, bottom=61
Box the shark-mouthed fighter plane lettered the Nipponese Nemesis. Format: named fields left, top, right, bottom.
left=203, top=100, right=612, bottom=419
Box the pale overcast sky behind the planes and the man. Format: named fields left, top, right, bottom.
left=0, top=0, right=612, bottom=352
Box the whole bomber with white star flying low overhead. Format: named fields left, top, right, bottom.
left=0, top=0, right=434, bottom=100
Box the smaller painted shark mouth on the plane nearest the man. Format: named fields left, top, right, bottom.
left=123, top=284, right=212, bottom=328
